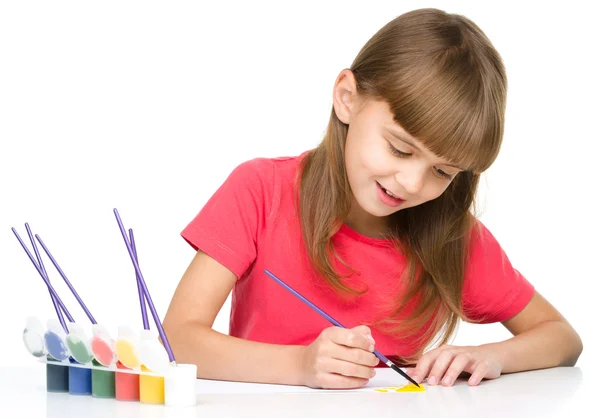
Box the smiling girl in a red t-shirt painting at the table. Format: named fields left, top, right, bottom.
left=164, top=9, right=582, bottom=388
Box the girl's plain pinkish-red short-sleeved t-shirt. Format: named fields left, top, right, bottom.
left=181, top=156, right=534, bottom=356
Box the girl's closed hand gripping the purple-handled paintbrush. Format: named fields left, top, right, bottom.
left=301, top=325, right=379, bottom=389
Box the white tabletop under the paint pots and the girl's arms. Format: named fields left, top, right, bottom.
left=0, top=364, right=600, bottom=418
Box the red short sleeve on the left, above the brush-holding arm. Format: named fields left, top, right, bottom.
left=181, top=158, right=274, bottom=279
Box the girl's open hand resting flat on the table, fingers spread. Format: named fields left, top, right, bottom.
left=407, top=345, right=503, bottom=386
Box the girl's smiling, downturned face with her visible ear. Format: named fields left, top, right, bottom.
left=334, top=70, right=462, bottom=230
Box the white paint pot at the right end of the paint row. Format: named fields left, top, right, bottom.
left=165, top=364, right=198, bottom=407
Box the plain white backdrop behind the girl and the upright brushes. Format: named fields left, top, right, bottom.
left=0, top=0, right=600, bottom=368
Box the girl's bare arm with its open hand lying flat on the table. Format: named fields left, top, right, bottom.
left=409, top=292, right=583, bottom=386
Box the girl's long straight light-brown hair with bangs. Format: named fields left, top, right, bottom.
left=298, top=9, right=507, bottom=363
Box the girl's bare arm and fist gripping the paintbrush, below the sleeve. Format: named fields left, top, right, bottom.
left=164, top=251, right=378, bottom=388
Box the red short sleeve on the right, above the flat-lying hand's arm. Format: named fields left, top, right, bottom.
left=463, top=221, right=534, bottom=323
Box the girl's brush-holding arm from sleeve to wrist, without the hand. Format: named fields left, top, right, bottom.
left=163, top=251, right=300, bottom=384
